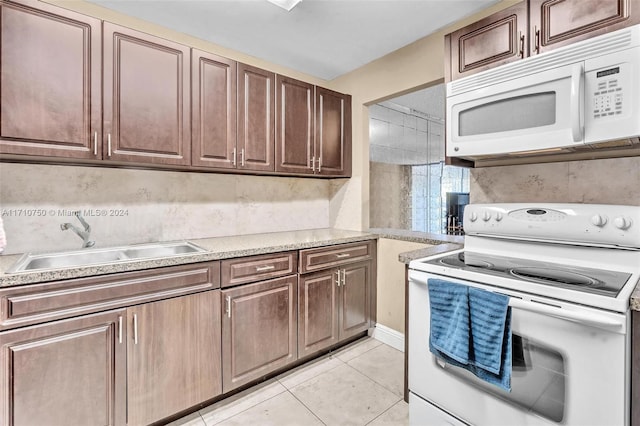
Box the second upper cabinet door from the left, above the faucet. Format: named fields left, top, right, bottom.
left=103, top=22, right=191, bottom=165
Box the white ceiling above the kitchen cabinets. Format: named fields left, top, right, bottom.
left=88, top=0, right=499, bottom=80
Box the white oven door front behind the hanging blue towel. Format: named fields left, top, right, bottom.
left=408, top=270, right=629, bottom=426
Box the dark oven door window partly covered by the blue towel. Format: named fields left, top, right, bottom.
left=434, top=334, right=567, bottom=423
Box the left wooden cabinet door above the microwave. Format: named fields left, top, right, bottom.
left=445, top=1, right=528, bottom=81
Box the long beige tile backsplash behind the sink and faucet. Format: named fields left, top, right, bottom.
left=0, top=163, right=330, bottom=254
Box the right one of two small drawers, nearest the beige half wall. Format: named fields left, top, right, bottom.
left=300, top=240, right=376, bottom=274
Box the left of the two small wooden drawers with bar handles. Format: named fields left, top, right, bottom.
left=220, top=251, right=298, bottom=288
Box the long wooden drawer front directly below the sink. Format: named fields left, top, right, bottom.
left=0, top=261, right=220, bottom=330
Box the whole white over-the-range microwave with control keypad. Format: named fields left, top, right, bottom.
left=446, top=25, right=640, bottom=159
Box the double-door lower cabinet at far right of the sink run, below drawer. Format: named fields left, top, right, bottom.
left=298, top=261, right=372, bottom=358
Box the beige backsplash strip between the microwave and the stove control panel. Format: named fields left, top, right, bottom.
left=470, top=157, right=640, bottom=206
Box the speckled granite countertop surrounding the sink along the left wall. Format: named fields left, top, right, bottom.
left=0, top=229, right=378, bottom=287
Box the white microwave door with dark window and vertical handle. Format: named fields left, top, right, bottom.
left=446, top=62, right=584, bottom=157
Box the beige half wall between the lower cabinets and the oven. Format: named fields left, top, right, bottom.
left=376, top=238, right=429, bottom=334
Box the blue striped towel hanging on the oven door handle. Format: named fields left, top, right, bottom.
left=428, top=279, right=511, bottom=391
